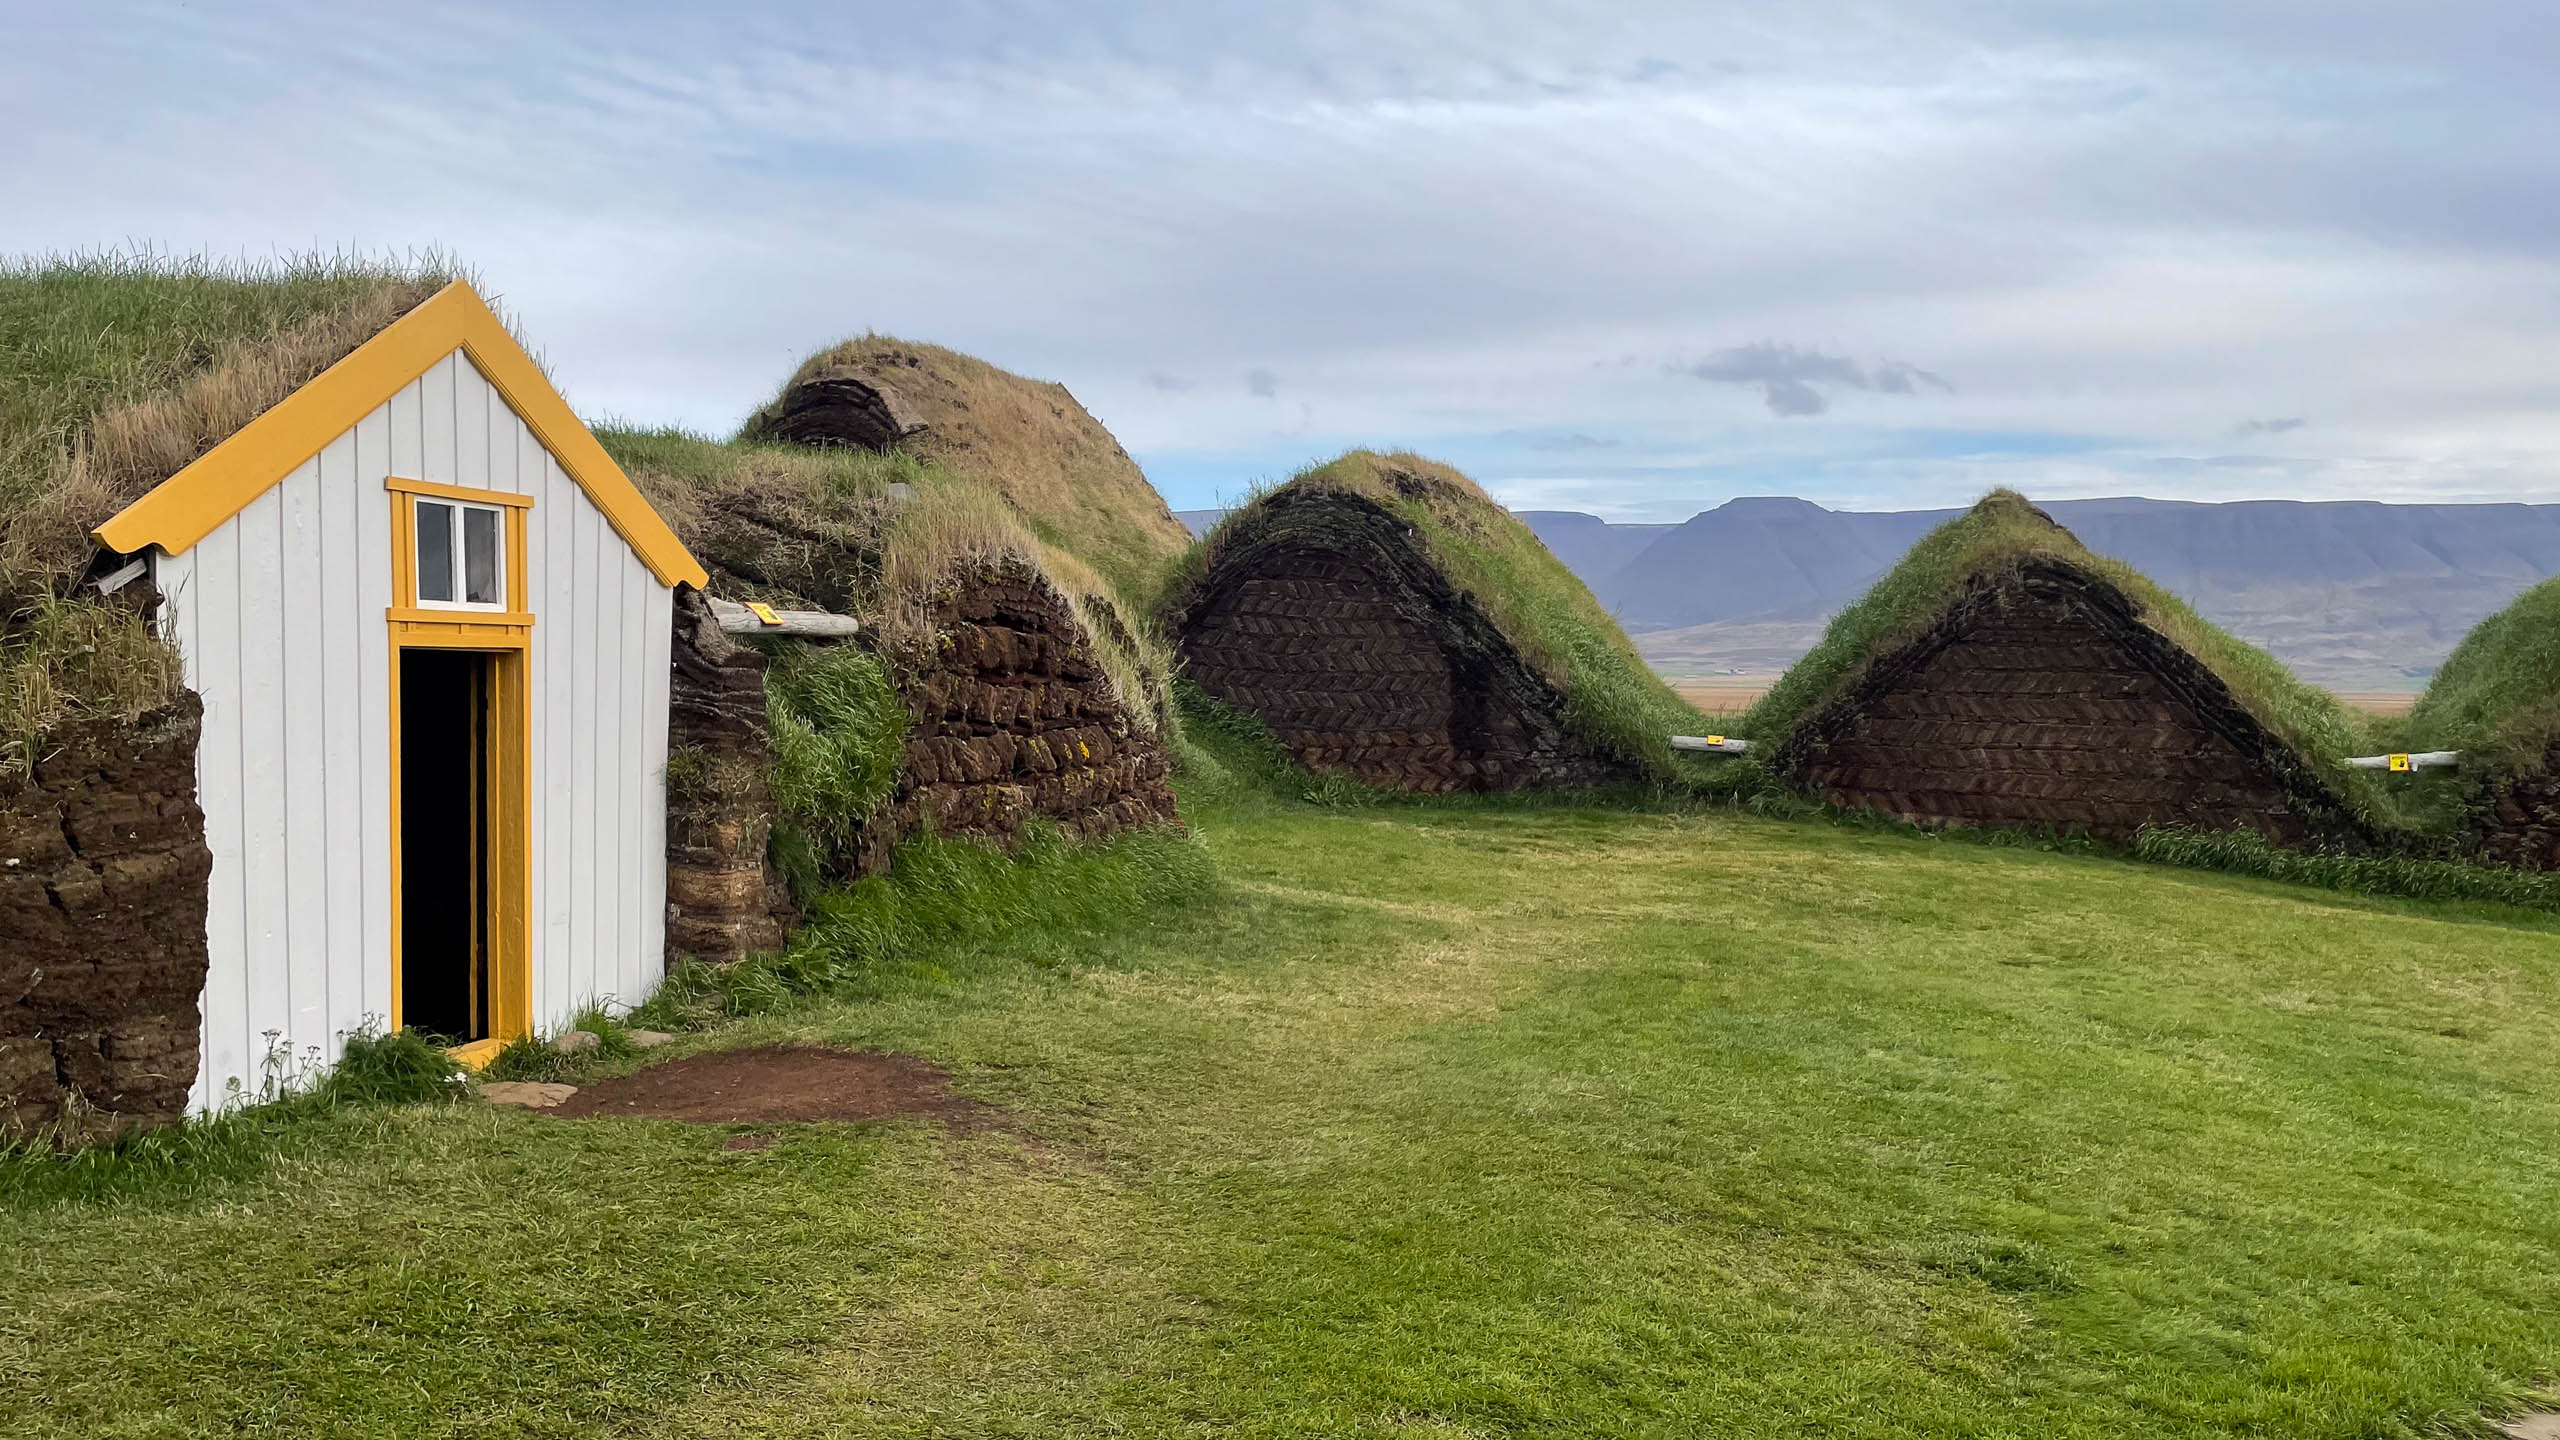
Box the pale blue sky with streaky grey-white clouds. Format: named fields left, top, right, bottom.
left=0, top=0, right=2560, bottom=520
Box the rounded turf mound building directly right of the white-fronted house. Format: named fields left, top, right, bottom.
left=619, top=341, right=1178, bottom=961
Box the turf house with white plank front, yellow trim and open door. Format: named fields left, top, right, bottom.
left=0, top=266, right=704, bottom=1127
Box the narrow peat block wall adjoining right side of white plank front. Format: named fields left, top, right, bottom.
left=666, top=589, right=799, bottom=963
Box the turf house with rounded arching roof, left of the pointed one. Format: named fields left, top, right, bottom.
left=1165, top=451, right=1700, bottom=792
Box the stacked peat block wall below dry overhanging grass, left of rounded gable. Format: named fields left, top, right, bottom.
left=873, top=564, right=1178, bottom=846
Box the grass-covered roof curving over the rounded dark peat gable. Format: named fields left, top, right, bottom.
left=1160, top=451, right=1705, bottom=779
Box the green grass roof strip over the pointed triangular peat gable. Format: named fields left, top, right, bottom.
left=1736, top=489, right=2391, bottom=825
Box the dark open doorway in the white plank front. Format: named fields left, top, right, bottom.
left=399, top=648, right=497, bottom=1043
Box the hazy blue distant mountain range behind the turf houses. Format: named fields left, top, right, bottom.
left=1521, top=497, right=2560, bottom=689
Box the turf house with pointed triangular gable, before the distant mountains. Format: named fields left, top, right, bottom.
left=1741, top=492, right=2376, bottom=848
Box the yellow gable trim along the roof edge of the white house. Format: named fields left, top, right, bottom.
left=97, top=279, right=709, bottom=589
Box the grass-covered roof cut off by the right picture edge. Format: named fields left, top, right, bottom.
left=2409, top=579, right=2560, bottom=776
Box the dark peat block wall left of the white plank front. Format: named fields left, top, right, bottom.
left=0, top=694, right=212, bottom=1135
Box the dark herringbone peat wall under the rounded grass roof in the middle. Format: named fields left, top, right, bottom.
left=1175, top=495, right=1631, bottom=794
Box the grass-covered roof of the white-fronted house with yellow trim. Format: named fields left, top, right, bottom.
left=0, top=254, right=456, bottom=771
